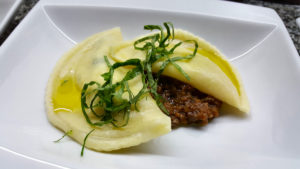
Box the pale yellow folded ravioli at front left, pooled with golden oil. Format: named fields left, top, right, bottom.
left=46, top=28, right=171, bottom=151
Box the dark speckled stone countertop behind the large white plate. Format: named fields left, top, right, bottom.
left=0, top=0, right=300, bottom=54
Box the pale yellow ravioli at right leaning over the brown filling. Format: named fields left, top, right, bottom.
left=113, top=29, right=250, bottom=113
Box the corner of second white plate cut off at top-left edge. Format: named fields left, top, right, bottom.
left=0, top=0, right=22, bottom=34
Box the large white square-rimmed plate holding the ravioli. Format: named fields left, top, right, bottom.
left=0, top=0, right=300, bottom=169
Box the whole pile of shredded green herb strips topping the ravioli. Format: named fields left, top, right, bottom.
left=81, top=22, right=198, bottom=154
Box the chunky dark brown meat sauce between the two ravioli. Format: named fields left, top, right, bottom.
left=157, top=76, right=222, bottom=128
